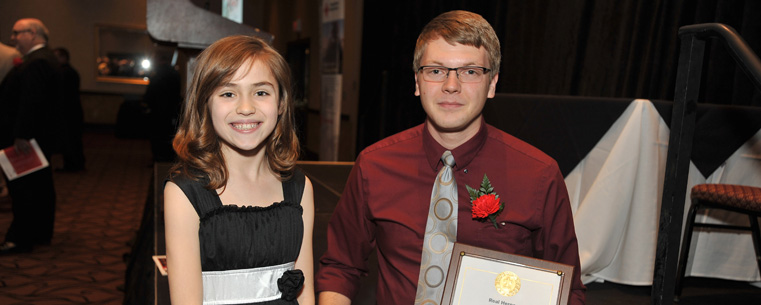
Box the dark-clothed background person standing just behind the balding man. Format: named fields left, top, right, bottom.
left=53, top=48, right=85, bottom=172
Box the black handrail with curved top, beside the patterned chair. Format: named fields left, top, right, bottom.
left=651, top=23, right=761, bottom=305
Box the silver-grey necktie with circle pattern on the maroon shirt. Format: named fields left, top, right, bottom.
left=415, top=150, right=457, bottom=305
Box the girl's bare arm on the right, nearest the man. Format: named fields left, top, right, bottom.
left=296, top=177, right=315, bottom=305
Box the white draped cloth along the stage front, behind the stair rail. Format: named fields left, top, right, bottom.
left=565, top=100, right=761, bottom=285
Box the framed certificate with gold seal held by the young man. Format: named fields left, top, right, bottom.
left=441, top=243, right=573, bottom=305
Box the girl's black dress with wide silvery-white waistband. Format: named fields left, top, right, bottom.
left=169, top=169, right=305, bottom=304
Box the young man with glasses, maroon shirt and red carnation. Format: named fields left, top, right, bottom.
left=317, top=11, right=585, bottom=305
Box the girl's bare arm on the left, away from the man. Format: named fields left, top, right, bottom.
left=164, top=182, right=203, bottom=305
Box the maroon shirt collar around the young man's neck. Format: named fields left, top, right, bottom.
left=423, top=119, right=489, bottom=171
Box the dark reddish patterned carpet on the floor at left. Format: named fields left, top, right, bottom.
left=0, top=132, right=152, bottom=305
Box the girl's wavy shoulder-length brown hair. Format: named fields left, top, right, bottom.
left=172, top=35, right=299, bottom=189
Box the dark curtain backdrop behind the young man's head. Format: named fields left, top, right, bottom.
left=357, top=0, right=761, bottom=152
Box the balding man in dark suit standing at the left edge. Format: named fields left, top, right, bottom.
left=0, top=18, right=62, bottom=254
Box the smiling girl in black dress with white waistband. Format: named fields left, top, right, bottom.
left=164, top=36, right=314, bottom=305
